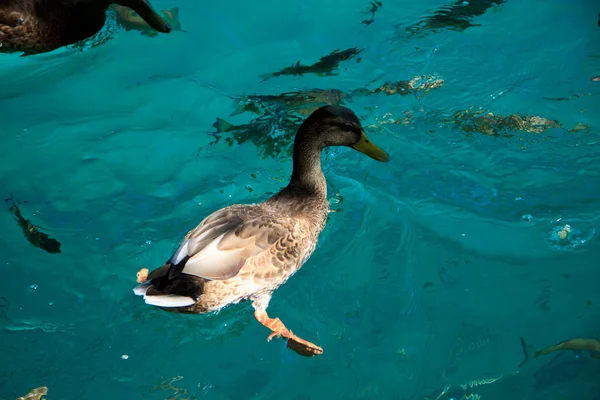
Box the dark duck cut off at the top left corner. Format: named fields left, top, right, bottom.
left=0, top=0, right=171, bottom=56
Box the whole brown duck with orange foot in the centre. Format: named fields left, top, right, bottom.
left=133, top=105, right=389, bottom=357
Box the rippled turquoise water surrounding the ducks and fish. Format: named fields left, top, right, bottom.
left=0, top=0, right=600, bottom=400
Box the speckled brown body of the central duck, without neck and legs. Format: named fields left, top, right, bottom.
left=140, top=199, right=329, bottom=314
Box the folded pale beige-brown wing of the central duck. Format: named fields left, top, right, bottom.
left=169, top=206, right=298, bottom=280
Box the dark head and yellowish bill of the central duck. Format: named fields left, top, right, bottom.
left=294, top=105, right=389, bottom=162
